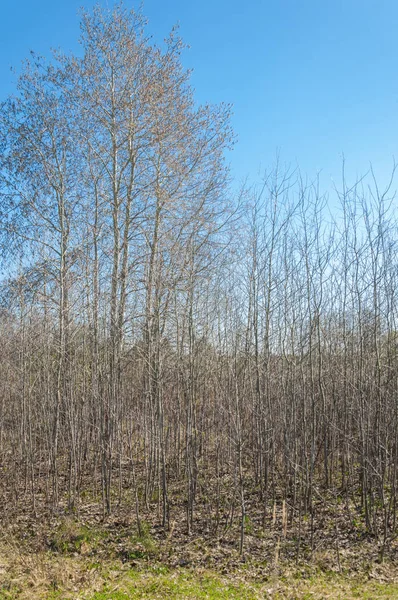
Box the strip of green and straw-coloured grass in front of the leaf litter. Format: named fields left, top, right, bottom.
left=0, top=541, right=398, bottom=600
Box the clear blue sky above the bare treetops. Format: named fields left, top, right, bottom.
left=0, top=0, right=398, bottom=186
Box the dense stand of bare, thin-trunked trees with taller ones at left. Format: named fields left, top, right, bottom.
left=0, top=6, right=398, bottom=550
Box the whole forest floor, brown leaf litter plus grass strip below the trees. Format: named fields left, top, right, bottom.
left=5, top=468, right=398, bottom=600
